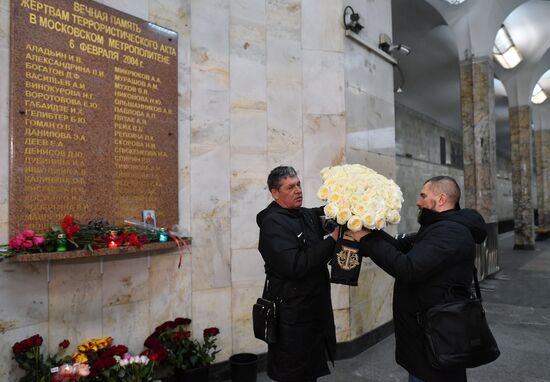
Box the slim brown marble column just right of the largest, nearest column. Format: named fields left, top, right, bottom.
left=509, top=106, right=534, bottom=249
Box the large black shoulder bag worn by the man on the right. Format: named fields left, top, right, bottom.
left=417, top=267, right=500, bottom=370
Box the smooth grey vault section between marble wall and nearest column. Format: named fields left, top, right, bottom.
left=392, top=0, right=461, bottom=130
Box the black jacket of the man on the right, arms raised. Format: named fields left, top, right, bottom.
left=360, top=209, right=486, bottom=382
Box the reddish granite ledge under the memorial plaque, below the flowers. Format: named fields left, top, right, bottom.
left=10, top=242, right=191, bottom=263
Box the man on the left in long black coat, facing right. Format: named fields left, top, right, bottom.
left=256, top=166, right=338, bottom=382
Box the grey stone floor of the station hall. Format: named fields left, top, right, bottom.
left=258, top=233, right=550, bottom=382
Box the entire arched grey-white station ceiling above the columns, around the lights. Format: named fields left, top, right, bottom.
left=392, top=0, right=550, bottom=157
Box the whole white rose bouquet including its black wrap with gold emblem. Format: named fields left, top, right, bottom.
left=317, top=164, right=403, bottom=286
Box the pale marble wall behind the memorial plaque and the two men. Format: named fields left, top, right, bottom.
left=0, top=0, right=396, bottom=381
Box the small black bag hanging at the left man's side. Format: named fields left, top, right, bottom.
left=252, top=275, right=277, bottom=344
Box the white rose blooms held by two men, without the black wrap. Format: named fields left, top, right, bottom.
left=317, top=164, right=403, bottom=232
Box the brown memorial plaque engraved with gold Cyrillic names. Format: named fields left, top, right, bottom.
left=9, top=0, right=178, bottom=234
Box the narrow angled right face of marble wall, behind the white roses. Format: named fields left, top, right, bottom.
left=344, top=0, right=397, bottom=341
